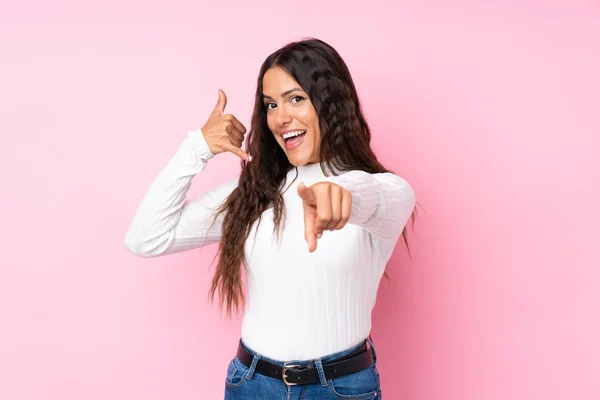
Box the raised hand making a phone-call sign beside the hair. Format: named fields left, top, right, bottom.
left=201, top=89, right=252, bottom=161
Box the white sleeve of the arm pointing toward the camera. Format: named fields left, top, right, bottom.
left=327, top=170, right=416, bottom=245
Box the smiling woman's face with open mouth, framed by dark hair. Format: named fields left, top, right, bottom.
left=263, top=67, right=321, bottom=166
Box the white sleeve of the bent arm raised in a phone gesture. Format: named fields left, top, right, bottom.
left=125, top=129, right=238, bottom=257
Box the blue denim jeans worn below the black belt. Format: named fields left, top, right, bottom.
left=225, top=338, right=381, bottom=400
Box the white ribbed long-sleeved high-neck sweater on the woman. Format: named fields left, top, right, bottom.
left=125, top=129, right=415, bottom=361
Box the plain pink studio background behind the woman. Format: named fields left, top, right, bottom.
left=0, top=0, right=600, bottom=400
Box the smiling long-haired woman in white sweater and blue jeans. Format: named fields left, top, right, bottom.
left=125, top=39, right=415, bottom=400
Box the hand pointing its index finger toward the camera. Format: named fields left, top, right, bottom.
left=298, top=182, right=352, bottom=253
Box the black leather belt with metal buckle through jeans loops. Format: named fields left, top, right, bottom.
left=237, top=339, right=374, bottom=385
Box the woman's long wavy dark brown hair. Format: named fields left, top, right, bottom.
left=209, top=38, right=415, bottom=316
